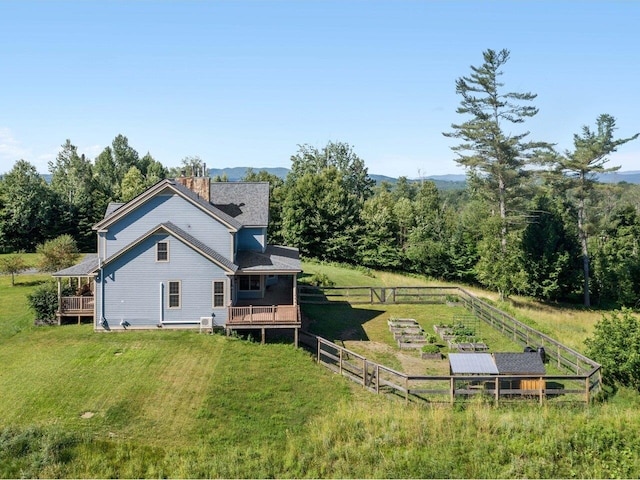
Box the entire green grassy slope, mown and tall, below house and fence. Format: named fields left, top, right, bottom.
left=0, top=265, right=640, bottom=478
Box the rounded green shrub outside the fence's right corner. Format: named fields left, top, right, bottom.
left=585, top=309, right=640, bottom=392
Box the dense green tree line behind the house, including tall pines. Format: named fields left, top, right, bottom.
left=0, top=50, right=640, bottom=306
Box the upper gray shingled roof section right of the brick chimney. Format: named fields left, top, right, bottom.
left=211, top=182, right=269, bottom=227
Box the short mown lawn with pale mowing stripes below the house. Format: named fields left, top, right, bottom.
left=0, top=276, right=353, bottom=477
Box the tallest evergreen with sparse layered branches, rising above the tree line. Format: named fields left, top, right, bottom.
left=444, top=50, right=549, bottom=293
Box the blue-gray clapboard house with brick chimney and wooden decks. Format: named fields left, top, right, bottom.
left=54, top=177, right=301, bottom=343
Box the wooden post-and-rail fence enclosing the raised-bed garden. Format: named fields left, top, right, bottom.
left=299, top=286, right=602, bottom=404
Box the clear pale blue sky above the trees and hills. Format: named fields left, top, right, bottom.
left=0, top=0, right=640, bottom=177
